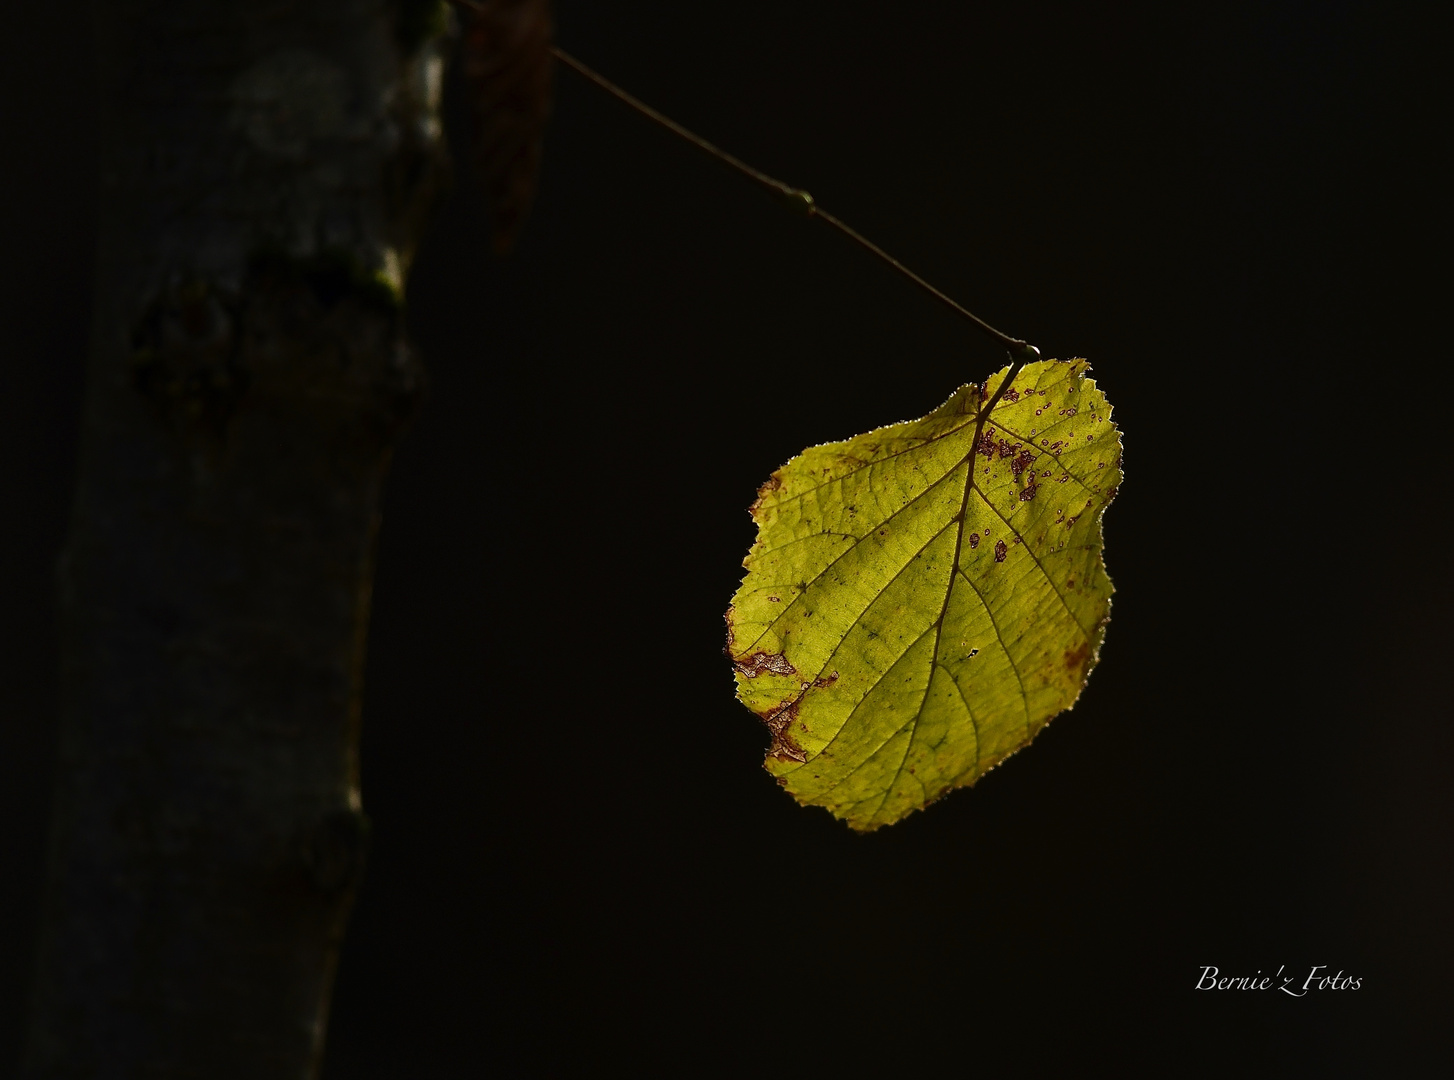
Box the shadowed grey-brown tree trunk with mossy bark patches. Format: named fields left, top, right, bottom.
left=23, top=0, right=448, bottom=1080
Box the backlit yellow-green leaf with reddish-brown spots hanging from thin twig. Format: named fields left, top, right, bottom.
left=727, top=360, right=1121, bottom=830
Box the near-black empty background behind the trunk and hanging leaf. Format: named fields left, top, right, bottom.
left=0, top=0, right=1454, bottom=1080
